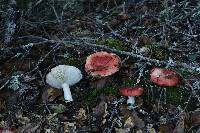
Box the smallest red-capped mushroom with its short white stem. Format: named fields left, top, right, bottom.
left=120, top=86, right=144, bottom=105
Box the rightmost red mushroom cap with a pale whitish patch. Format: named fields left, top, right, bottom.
left=151, top=68, right=180, bottom=87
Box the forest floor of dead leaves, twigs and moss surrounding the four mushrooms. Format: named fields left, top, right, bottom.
left=0, top=0, right=200, bottom=133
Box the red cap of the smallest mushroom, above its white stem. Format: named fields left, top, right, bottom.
left=120, top=86, right=144, bottom=96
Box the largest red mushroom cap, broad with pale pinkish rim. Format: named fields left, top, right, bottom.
left=85, top=51, right=121, bottom=77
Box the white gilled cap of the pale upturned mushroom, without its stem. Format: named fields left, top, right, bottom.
left=46, top=65, right=82, bottom=89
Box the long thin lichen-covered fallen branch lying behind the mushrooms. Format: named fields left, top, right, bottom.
left=2, top=36, right=200, bottom=73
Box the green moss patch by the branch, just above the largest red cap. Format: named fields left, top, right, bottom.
left=96, top=38, right=127, bottom=51
